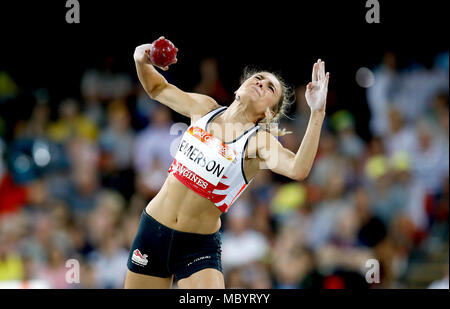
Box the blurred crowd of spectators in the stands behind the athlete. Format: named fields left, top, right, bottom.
left=0, top=52, right=449, bottom=289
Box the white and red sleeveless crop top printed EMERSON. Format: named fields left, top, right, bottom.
left=169, top=107, right=259, bottom=212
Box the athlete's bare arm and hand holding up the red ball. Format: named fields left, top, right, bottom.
left=133, top=44, right=219, bottom=118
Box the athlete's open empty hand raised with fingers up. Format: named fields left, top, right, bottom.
left=305, top=59, right=330, bottom=111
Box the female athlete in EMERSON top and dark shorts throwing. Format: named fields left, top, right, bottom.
left=125, top=37, right=329, bottom=289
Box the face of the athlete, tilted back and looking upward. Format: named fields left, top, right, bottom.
left=236, top=72, right=282, bottom=119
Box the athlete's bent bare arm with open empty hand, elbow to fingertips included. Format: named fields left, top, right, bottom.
left=257, top=59, right=329, bottom=180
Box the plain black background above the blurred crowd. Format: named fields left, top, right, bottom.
left=0, top=0, right=448, bottom=139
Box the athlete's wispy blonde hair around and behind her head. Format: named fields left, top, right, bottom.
left=240, top=66, right=295, bottom=135
